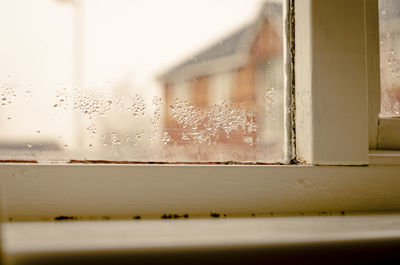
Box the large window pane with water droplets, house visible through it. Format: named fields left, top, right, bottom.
left=0, top=0, right=288, bottom=163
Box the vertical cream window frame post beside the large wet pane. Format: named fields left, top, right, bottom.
left=295, top=0, right=369, bottom=165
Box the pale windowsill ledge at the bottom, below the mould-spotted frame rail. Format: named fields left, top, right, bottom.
left=3, top=214, right=400, bottom=264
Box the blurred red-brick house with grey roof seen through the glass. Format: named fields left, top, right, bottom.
left=160, top=2, right=284, bottom=161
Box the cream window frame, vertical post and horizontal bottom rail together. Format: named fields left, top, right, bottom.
left=0, top=0, right=400, bottom=221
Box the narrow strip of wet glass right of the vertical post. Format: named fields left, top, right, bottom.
left=379, top=0, right=400, bottom=117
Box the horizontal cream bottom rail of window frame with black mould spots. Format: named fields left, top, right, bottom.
left=0, top=164, right=400, bottom=221
